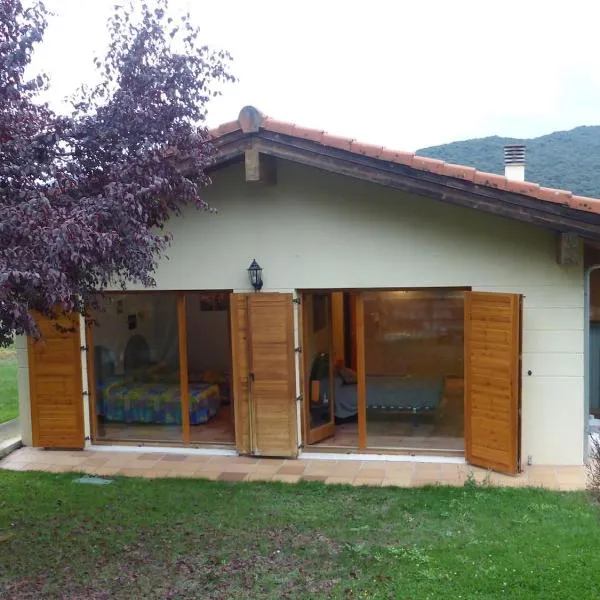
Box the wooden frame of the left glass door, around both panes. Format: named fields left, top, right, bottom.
left=87, top=289, right=237, bottom=449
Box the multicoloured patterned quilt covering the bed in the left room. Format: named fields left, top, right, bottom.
left=97, top=377, right=220, bottom=425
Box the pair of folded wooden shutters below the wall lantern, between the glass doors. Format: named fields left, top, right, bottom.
left=231, top=293, right=298, bottom=456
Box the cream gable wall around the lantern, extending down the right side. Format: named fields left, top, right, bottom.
left=138, top=161, right=584, bottom=464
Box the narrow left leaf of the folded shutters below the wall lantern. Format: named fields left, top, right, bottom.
left=229, top=294, right=252, bottom=454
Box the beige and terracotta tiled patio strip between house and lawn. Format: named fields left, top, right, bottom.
left=0, top=448, right=586, bottom=490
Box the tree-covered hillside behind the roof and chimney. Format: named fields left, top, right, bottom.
left=417, top=126, right=600, bottom=198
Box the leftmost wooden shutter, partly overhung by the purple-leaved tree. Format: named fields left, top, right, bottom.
left=29, top=315, right=85, bottom=448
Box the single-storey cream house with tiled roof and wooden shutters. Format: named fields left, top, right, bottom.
left=18, top=107, right=600, bottom=473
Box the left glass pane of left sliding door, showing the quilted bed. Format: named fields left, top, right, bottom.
left=91, top=293, right=184, bottom=442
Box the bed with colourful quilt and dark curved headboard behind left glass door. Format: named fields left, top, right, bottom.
left=95, top=335, right=221, bottom=425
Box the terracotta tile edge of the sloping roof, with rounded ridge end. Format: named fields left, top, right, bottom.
left=209, top=106, right=600, bottom=214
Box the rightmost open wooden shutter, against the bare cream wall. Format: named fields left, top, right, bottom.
left=465, top=292, right=521, bottom=473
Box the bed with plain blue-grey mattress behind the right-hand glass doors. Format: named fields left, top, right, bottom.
left=320, top=375, right=444, bottom=419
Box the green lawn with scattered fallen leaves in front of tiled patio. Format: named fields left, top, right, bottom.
left=0, top=471, right=600, bottom=600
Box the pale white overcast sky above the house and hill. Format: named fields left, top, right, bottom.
left=32, top=0, right=600, bottom=151
